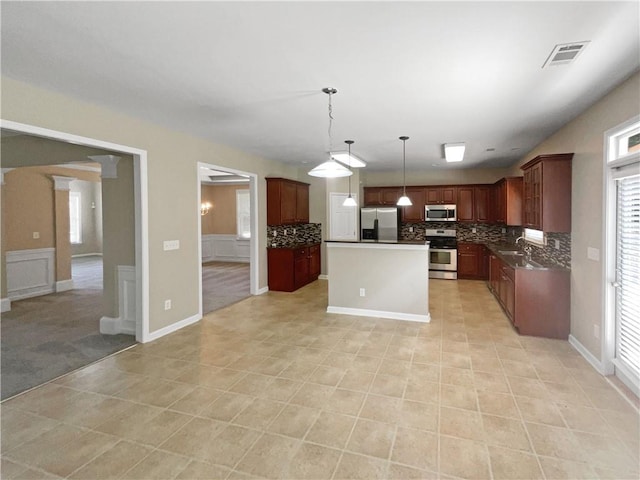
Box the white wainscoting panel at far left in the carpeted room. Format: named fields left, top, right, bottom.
left=6, top=248, right=55, bottom=300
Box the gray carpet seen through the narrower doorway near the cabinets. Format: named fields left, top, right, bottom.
left=202, top=262, right=251, bottom=315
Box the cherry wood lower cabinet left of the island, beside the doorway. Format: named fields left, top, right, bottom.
left=267, top=244, right=320, bottom=292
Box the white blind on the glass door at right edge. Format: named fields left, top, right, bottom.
left=616, top=175, right=640, bottom=377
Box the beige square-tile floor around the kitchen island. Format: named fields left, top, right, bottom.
left=1, top=281, right=639, bottom=479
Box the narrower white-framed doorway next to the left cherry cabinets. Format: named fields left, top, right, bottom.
left=198, top=163, right=259, bottom=315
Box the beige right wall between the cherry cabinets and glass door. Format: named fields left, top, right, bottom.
left=510, top=73, right=640, bottom=359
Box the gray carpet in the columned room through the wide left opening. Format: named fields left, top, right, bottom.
left=0, top=257, right=136, bottom=400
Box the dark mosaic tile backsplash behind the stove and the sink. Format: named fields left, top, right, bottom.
left=400, top=222, right=571, bottom=268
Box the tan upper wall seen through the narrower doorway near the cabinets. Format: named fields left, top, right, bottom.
left=200, top=184, right=249, bottom=235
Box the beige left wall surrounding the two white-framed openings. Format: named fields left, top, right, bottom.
left=1, top=77, right=297, bottom=332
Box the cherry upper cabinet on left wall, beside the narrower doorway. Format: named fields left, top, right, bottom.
left=266, top=178, right=309, bottom=225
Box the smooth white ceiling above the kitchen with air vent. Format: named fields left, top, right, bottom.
left=2, top=1, right=640, bottom=172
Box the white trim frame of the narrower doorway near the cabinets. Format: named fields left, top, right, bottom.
left=194, top=162, right=258, bottom=318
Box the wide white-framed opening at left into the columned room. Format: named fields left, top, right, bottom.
left=0, top=120, right=148, bottom=399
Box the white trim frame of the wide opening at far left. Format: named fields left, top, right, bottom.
left=0, top=119, right=152, bottom=343
